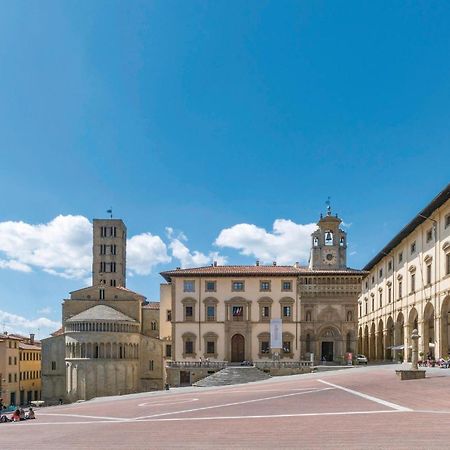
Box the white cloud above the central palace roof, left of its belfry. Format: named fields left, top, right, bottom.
left=215, top=219, right=317, bottom=264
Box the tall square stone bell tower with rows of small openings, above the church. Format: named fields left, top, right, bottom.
left=92, top=219, right=127, bottom=287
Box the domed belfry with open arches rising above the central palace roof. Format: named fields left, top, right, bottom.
left=309, top=203, right=347, bottom=270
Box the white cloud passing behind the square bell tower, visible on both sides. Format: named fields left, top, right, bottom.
left=0, top=215, right=171, bottom=285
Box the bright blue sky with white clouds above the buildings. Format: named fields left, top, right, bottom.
left=0, top=0, right=450, bottom=335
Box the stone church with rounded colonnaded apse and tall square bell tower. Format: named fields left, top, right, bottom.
left=42, top=219, right=163, bottom=403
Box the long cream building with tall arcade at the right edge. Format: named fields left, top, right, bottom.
left=358, top=185, right=450, bottom=361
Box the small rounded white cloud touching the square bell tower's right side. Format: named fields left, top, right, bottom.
left=127, top=233, right=171, bottom=275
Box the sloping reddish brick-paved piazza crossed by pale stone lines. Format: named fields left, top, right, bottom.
left=0, top=365, right=450, bottom=449
